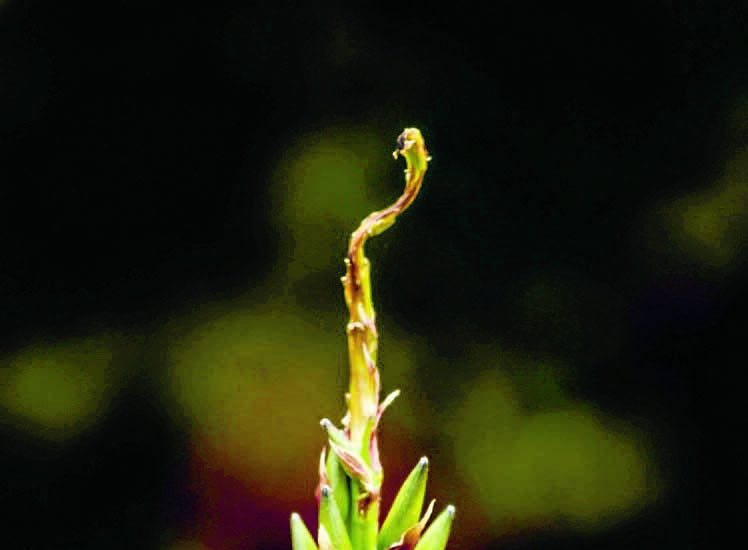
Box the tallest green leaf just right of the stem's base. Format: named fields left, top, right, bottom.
left=377, top=457, right=429, bottom=550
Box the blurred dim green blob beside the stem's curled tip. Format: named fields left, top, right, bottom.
left=271, top=126, right=400, bottom=281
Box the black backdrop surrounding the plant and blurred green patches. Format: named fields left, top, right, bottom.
left=0, top=0, right=748, bottom=549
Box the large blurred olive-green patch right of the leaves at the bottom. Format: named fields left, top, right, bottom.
left=450, top=373, right=658, bottom=532
